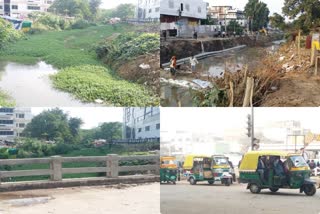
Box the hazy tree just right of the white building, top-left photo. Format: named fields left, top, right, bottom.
left=50, top=0, right=92, bottom=19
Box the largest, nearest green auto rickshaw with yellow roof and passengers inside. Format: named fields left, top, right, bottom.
left=239, top=151, right=316, bottom=196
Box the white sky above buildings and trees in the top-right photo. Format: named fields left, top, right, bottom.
left=205, top=0, right=284, bottom=15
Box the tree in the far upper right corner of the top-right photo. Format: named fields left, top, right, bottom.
left=282, top=0, right=320, bottom=29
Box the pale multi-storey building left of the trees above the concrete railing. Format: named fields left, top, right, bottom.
left=0, top=108, right=32, bottom=141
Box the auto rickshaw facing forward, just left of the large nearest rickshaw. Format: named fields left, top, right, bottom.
left=211, top=155, right=233, bottom=186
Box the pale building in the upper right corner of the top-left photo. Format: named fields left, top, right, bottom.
left=136, top=0, right=160, bottom=21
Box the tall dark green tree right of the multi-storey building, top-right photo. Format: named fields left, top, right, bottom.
left=244, top=0, right=270, bottom=31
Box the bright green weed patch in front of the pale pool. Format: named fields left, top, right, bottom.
left=52, top=65, right=159, bottom=106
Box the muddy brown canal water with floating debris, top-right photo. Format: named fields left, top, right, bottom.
left=161, top=43, right=279, bottom=107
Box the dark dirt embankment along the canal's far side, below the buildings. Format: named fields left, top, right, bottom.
left=160, top=35, right=282, bottom=64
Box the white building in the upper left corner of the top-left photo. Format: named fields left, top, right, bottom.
left=0, top=0, right=54, bottom=19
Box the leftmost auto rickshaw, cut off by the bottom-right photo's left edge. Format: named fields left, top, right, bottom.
left=160, top=156, right=180, bottom=184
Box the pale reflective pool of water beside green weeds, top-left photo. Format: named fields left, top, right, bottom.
left=0, top=61, right=100, bottom=107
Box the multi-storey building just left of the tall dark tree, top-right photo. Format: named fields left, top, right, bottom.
left=208, top=6, right=248, bottom=27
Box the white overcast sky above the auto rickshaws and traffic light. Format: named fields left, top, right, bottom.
left=161, top=108, right=320, bottom=136
